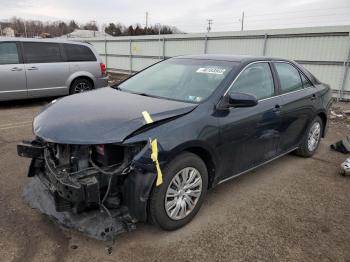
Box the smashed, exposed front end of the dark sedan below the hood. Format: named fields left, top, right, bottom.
left=17, top=138, right=156, bottom=240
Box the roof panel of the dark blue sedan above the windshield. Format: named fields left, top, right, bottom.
left=176, top=54, right=288, bottom=62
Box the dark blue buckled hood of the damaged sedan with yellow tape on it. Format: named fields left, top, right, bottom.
left=33, top=87, right=197, bottom=144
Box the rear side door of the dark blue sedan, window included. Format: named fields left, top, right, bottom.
left=273, top=62, right=317, bottom=151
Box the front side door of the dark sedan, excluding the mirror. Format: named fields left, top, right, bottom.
left=219, top=62, right=281, bottom=178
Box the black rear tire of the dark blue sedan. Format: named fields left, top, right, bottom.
left=295, top=116, right=323, bottom=157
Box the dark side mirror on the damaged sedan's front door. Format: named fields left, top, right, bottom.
left=219, top=92, right=258, bottom=109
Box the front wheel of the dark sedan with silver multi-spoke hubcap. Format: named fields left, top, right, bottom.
left=149, top=152, right=208, bottom=230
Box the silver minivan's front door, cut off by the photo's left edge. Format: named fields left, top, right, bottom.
left=0, top=42, right=27, bottom=100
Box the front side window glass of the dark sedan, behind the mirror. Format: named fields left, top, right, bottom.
left=230, top=62, right=275, bottom=100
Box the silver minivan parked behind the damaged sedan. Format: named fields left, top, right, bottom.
left=0, top=38, right=108, bottom=101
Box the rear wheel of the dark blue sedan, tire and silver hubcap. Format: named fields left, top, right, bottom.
left=295, top=116, right=323, bottom=157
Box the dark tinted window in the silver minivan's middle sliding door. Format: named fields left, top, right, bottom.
left=23, top=42, right=62, bottom=64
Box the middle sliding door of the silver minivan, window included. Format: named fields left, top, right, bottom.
left=23, top=42, right=69, bottom=97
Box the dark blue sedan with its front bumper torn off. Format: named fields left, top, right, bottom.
left=17, top=55, right=332, bottom=239
